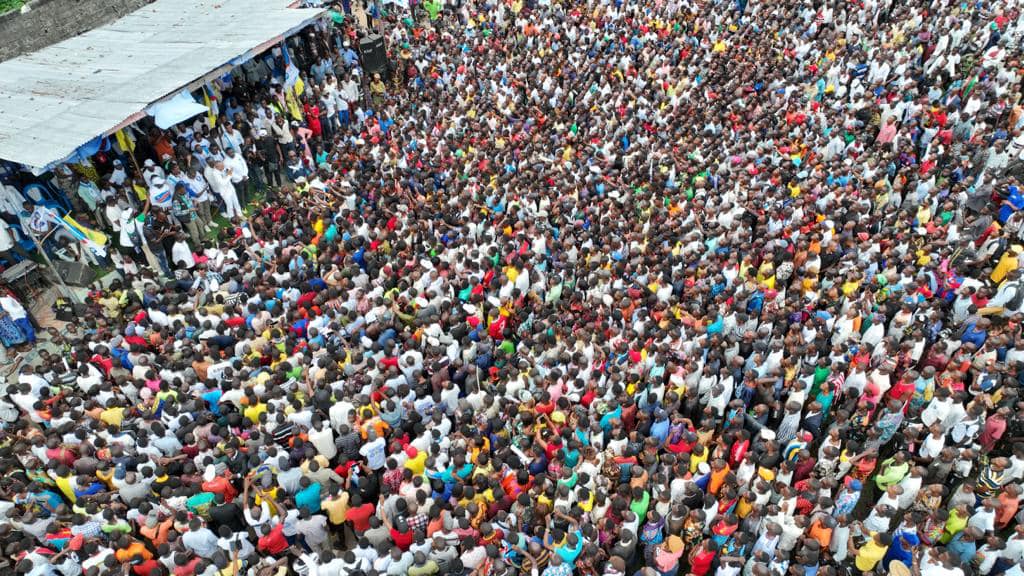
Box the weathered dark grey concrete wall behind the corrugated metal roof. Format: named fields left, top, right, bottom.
left=0, top=0, right=153, bottom=61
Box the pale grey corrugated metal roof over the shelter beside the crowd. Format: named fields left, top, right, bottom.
left=0, top=0, right=324, bottom=168
